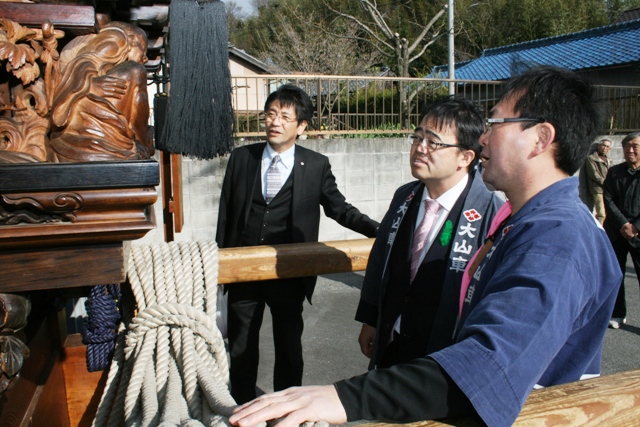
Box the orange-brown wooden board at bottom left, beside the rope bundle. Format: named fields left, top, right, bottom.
left=59, top=344, right=108, bottom=427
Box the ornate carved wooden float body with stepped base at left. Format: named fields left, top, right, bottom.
left=0, top=3, right=159, bottom=412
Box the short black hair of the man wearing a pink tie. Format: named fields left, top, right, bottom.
left=420, top=96, right=484, bottom=170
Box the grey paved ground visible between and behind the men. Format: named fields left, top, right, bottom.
left=258, top=263, right=640, bottom=391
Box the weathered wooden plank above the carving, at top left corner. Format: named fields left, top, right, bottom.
left=0, top=2, right=96, bottom=32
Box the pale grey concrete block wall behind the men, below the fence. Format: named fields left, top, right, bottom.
left=135, top=136, right=623, bottom=244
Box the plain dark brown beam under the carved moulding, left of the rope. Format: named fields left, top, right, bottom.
left=0, top=243, right=125, bottom=292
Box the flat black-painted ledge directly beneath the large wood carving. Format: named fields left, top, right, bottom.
left=0, top=160, right=160, bottom=194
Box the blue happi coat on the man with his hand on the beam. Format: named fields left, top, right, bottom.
left=430, top=177, right=621, bottom=427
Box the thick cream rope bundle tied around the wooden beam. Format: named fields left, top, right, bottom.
left=93, top=242, right=236, bottom=427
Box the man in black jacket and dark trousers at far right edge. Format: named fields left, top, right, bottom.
left=604, top=132, right=640, bottom=329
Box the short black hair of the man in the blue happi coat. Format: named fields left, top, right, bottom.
left=498, top=65, right=604, bottom=175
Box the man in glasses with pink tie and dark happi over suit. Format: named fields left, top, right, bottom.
left=356, top=97, right=502, bottom=369
